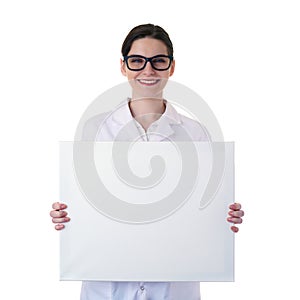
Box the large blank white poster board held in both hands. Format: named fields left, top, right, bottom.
left=60, top=142, right=234, bottom=281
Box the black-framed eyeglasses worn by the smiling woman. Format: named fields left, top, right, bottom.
left=124, top=54, right=173, bottom=71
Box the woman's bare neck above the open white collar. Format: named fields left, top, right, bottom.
left=129, top=98, right=166, bottom=131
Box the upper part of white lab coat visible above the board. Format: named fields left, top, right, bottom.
left=82, top=99, right=209, bottom=141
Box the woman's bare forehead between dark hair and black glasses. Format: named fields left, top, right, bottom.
left=128, top=37, right=168, bottom=57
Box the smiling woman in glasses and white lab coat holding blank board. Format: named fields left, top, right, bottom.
left=50, top=24, right=244, bottom=300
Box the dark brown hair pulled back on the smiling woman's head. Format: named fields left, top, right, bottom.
left=121, top=24, right=173, bottom=56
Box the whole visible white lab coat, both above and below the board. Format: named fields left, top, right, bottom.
left=80, top=99, right=209, bottom=300
